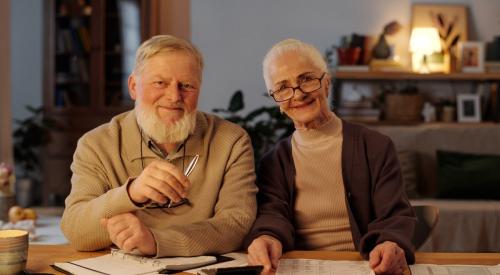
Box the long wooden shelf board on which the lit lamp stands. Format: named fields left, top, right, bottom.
left=332, top=71, right=500, bottom=81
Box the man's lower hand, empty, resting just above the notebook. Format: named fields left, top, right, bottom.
left=101, top=213, right=156, bottom=255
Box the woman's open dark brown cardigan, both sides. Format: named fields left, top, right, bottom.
left=245, top=121, right=416, bottom=264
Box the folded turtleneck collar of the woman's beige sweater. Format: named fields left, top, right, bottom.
left=293, top=113, right=342, bottom=146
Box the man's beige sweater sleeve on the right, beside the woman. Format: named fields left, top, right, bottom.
left=151, top=134, right=257, bottom=257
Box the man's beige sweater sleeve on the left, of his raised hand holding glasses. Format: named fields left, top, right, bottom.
left=61, top=136, right=143, bottom=251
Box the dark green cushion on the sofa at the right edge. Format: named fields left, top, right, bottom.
left=437, top=150, right=500, bottom=200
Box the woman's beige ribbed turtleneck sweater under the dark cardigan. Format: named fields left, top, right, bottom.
left=292, top=115, right=355, bottom=251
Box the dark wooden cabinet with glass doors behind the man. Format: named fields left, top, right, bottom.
left=42, top=0, right=150, bottom=205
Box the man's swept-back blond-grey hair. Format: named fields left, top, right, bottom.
left=134, top=35, right=203, bottom=74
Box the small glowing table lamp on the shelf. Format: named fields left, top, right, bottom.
left=410, top=28, right=441, bottom=73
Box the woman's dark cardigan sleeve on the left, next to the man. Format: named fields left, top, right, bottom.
left=244, top=142, right=295, bottom=251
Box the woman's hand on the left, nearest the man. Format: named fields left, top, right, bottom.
left=248, top=235, right=283, bottom=274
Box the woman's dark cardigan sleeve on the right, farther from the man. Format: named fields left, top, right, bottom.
left=360, top=138, right=416, bottom=264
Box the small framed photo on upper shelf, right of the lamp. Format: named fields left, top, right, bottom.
left=458, top=41, right=484, bottom=73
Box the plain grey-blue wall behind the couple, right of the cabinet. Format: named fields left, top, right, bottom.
left=191, top=0, right=500, bottom=111
